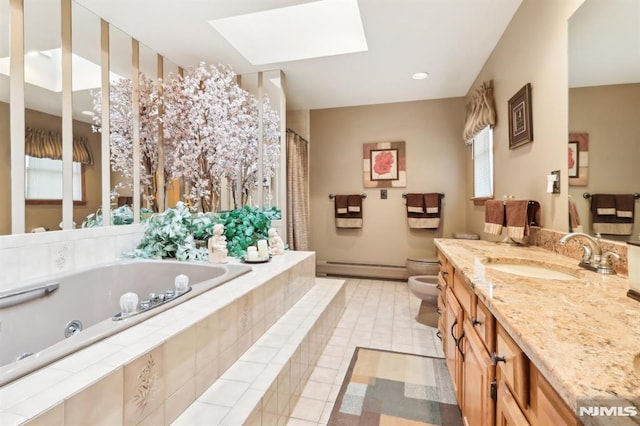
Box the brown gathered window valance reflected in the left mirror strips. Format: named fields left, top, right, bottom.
left=24, top=127, right=93, bottom=164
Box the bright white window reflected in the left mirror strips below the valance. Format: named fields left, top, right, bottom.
left=25, top=155, right=83, bottom=201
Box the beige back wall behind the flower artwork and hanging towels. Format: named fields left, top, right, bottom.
left=310, top=98, right=466, bottom=266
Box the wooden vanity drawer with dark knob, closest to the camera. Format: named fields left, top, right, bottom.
left=494, top=324, right=529, bottom=411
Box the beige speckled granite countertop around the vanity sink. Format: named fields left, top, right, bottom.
left=435, top=239, right=640, bottom=413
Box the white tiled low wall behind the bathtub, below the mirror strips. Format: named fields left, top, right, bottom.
left=0, top=225, right=144, bottom=290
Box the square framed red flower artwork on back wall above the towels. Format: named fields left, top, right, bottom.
left=362, top=142, right=407, bottom=188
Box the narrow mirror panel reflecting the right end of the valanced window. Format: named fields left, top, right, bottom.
left=71, top=2, right=102, bottom=226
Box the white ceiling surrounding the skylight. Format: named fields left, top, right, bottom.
left=75, top=0, right=521, bottom=109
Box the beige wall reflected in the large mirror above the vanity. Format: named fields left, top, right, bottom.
left=569, top=83, right=640, bottom=241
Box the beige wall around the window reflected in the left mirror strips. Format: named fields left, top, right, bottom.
left=0, top=103, right=101, bottom=234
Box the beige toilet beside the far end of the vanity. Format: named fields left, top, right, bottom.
left=406, top=232, right=480, bottom=327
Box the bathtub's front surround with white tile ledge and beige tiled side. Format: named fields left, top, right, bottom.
left=0, top=252, right=315, bottom=426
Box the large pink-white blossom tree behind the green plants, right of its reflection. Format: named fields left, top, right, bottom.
left=163, top=63, right=279, bottom=211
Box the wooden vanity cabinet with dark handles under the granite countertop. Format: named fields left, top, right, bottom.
left=438, top=253, right=580, bottom=426
